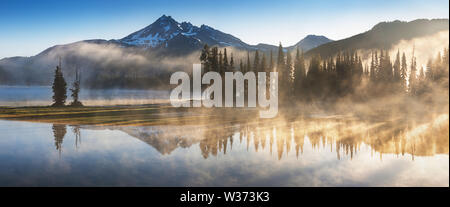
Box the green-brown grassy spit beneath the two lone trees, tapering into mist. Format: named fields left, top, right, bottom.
left=0, top=105, right=260, bottom=126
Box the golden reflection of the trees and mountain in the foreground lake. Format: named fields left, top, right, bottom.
left=53, top=114, right=449, bottom=160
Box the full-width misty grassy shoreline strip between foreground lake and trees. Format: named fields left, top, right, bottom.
left=0, top=99, right=448, bottom=126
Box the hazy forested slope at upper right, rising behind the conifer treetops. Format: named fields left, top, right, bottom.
left=306, top=19, right=449, bottom=57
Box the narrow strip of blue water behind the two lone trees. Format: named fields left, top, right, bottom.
left=0, top=86, right=169, bottom=106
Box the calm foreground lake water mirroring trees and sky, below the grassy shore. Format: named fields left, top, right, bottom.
left=0, top=114, right=449, bottom=186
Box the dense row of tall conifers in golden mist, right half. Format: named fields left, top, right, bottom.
left=200, top=43, right=449, bottom=101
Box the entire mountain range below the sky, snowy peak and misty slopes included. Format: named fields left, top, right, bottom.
left=0, top=15, right=449, bottom=88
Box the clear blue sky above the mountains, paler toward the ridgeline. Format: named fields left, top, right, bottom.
left=0, top=0, right=449, bottom=58
